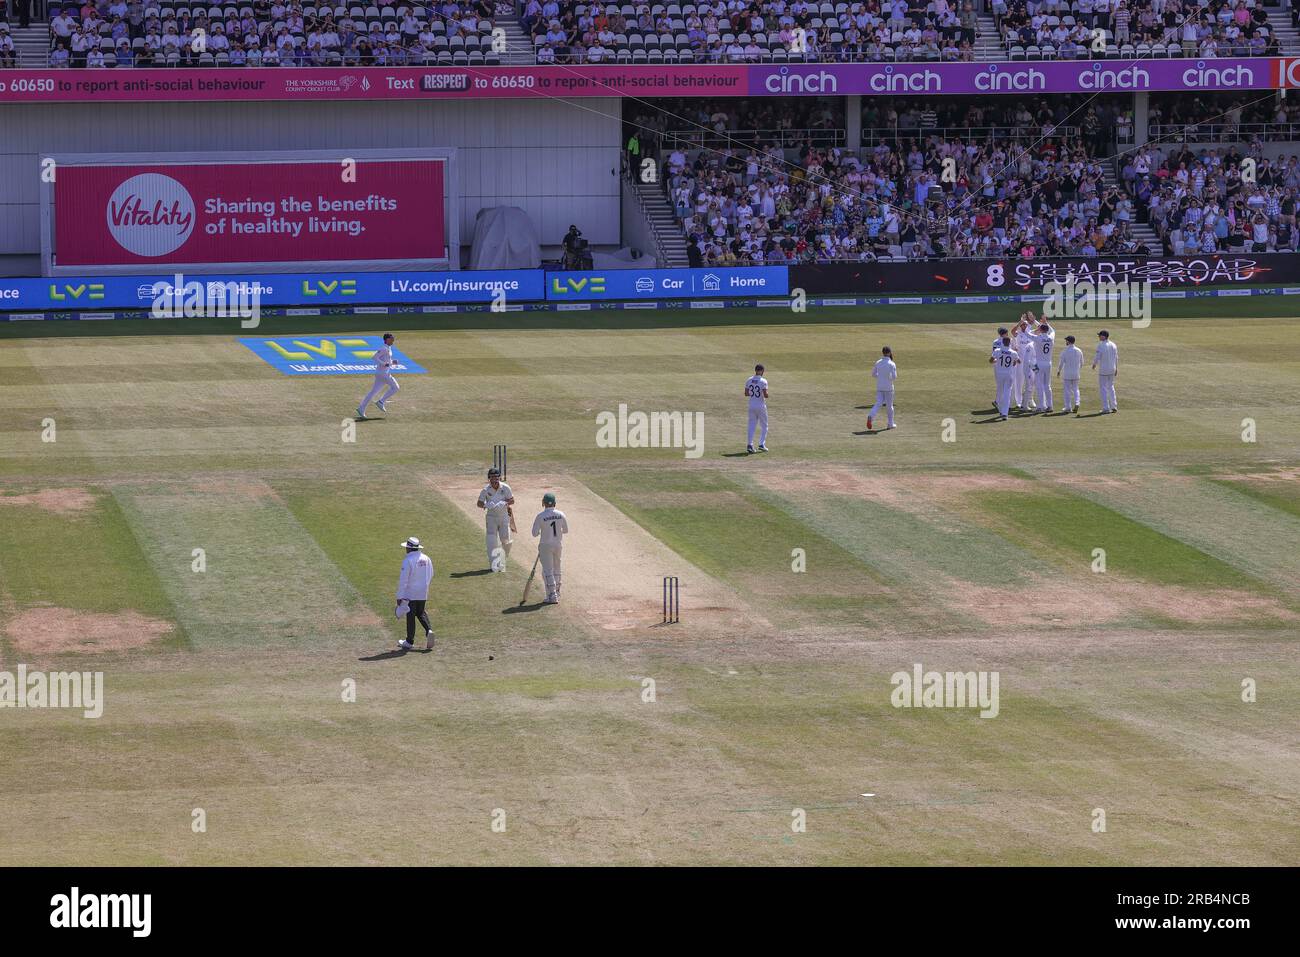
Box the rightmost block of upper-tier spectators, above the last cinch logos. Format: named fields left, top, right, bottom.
left=992, top=0, right=1279, bottom=60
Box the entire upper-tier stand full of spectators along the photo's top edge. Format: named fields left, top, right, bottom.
left=0, top=0, right=1296, bottom=66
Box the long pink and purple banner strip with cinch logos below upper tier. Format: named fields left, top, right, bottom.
left=0, top=57, right=1284, bottom=103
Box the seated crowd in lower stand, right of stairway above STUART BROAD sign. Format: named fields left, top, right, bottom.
left=1121, top=144, right=1300, bottom=256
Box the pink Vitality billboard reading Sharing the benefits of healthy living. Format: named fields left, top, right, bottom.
left=53, top=159, right=446, bottom=268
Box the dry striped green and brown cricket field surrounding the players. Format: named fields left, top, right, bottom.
left=0, top=296, right=1300, bottom=865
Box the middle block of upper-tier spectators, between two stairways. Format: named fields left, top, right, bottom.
left=521, top=0, right=978, bottom=62
